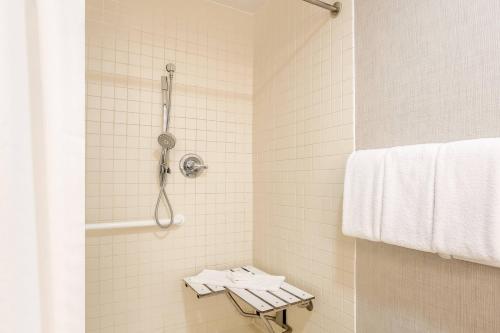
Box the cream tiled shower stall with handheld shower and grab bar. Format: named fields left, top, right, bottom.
left=86, top=0, right=354, bottom=333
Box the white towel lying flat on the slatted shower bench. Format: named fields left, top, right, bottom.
left=191, top=269, right=285, bottom=291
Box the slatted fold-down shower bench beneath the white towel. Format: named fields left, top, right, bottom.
left=184, top=266, right=314, bottom=333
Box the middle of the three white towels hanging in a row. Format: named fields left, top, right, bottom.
left=380, top=144, right=442, bottom=252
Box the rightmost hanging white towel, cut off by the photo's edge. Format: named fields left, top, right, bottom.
left=433, top=138, right=500, bottom=265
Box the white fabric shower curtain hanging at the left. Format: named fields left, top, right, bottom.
left=0, top=0, right=85, bottom=333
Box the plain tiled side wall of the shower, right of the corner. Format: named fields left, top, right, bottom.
left=253, top=0, right=355, bottom=333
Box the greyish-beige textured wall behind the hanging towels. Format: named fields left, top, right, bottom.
left=355, top=0, right=500, bottom=333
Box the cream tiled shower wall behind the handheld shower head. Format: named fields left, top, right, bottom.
left=86, top=0, right=253, bottom=333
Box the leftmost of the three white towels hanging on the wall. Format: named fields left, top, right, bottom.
left=342, top=149, right=387, bottom=241
